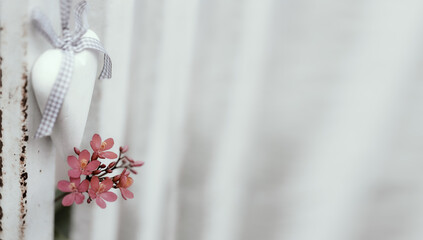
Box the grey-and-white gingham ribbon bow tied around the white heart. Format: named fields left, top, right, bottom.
left=32, top=0, right=112, bottom=138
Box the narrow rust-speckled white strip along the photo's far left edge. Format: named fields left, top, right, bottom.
left=0, top=0, right=28, bottom=239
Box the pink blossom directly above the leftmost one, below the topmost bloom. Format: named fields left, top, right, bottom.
left=68, top=150, right=101, bottom=178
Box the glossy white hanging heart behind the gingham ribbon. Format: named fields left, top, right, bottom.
left=31, top=30, right=99, bottom=157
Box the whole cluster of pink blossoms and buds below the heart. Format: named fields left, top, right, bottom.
left=57, top=134, right=144, bottom=208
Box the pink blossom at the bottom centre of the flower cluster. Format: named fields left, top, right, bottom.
left=88, top=176, right=117, bottom=208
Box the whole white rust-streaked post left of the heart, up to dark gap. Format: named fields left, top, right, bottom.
left=0, top=0, right=55, bottom=240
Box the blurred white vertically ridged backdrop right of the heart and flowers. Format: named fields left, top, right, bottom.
left=56, top=0, right=423, bottom=240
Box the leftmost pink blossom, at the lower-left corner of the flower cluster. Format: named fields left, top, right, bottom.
left=57, top=178, right=89, bottom=206
